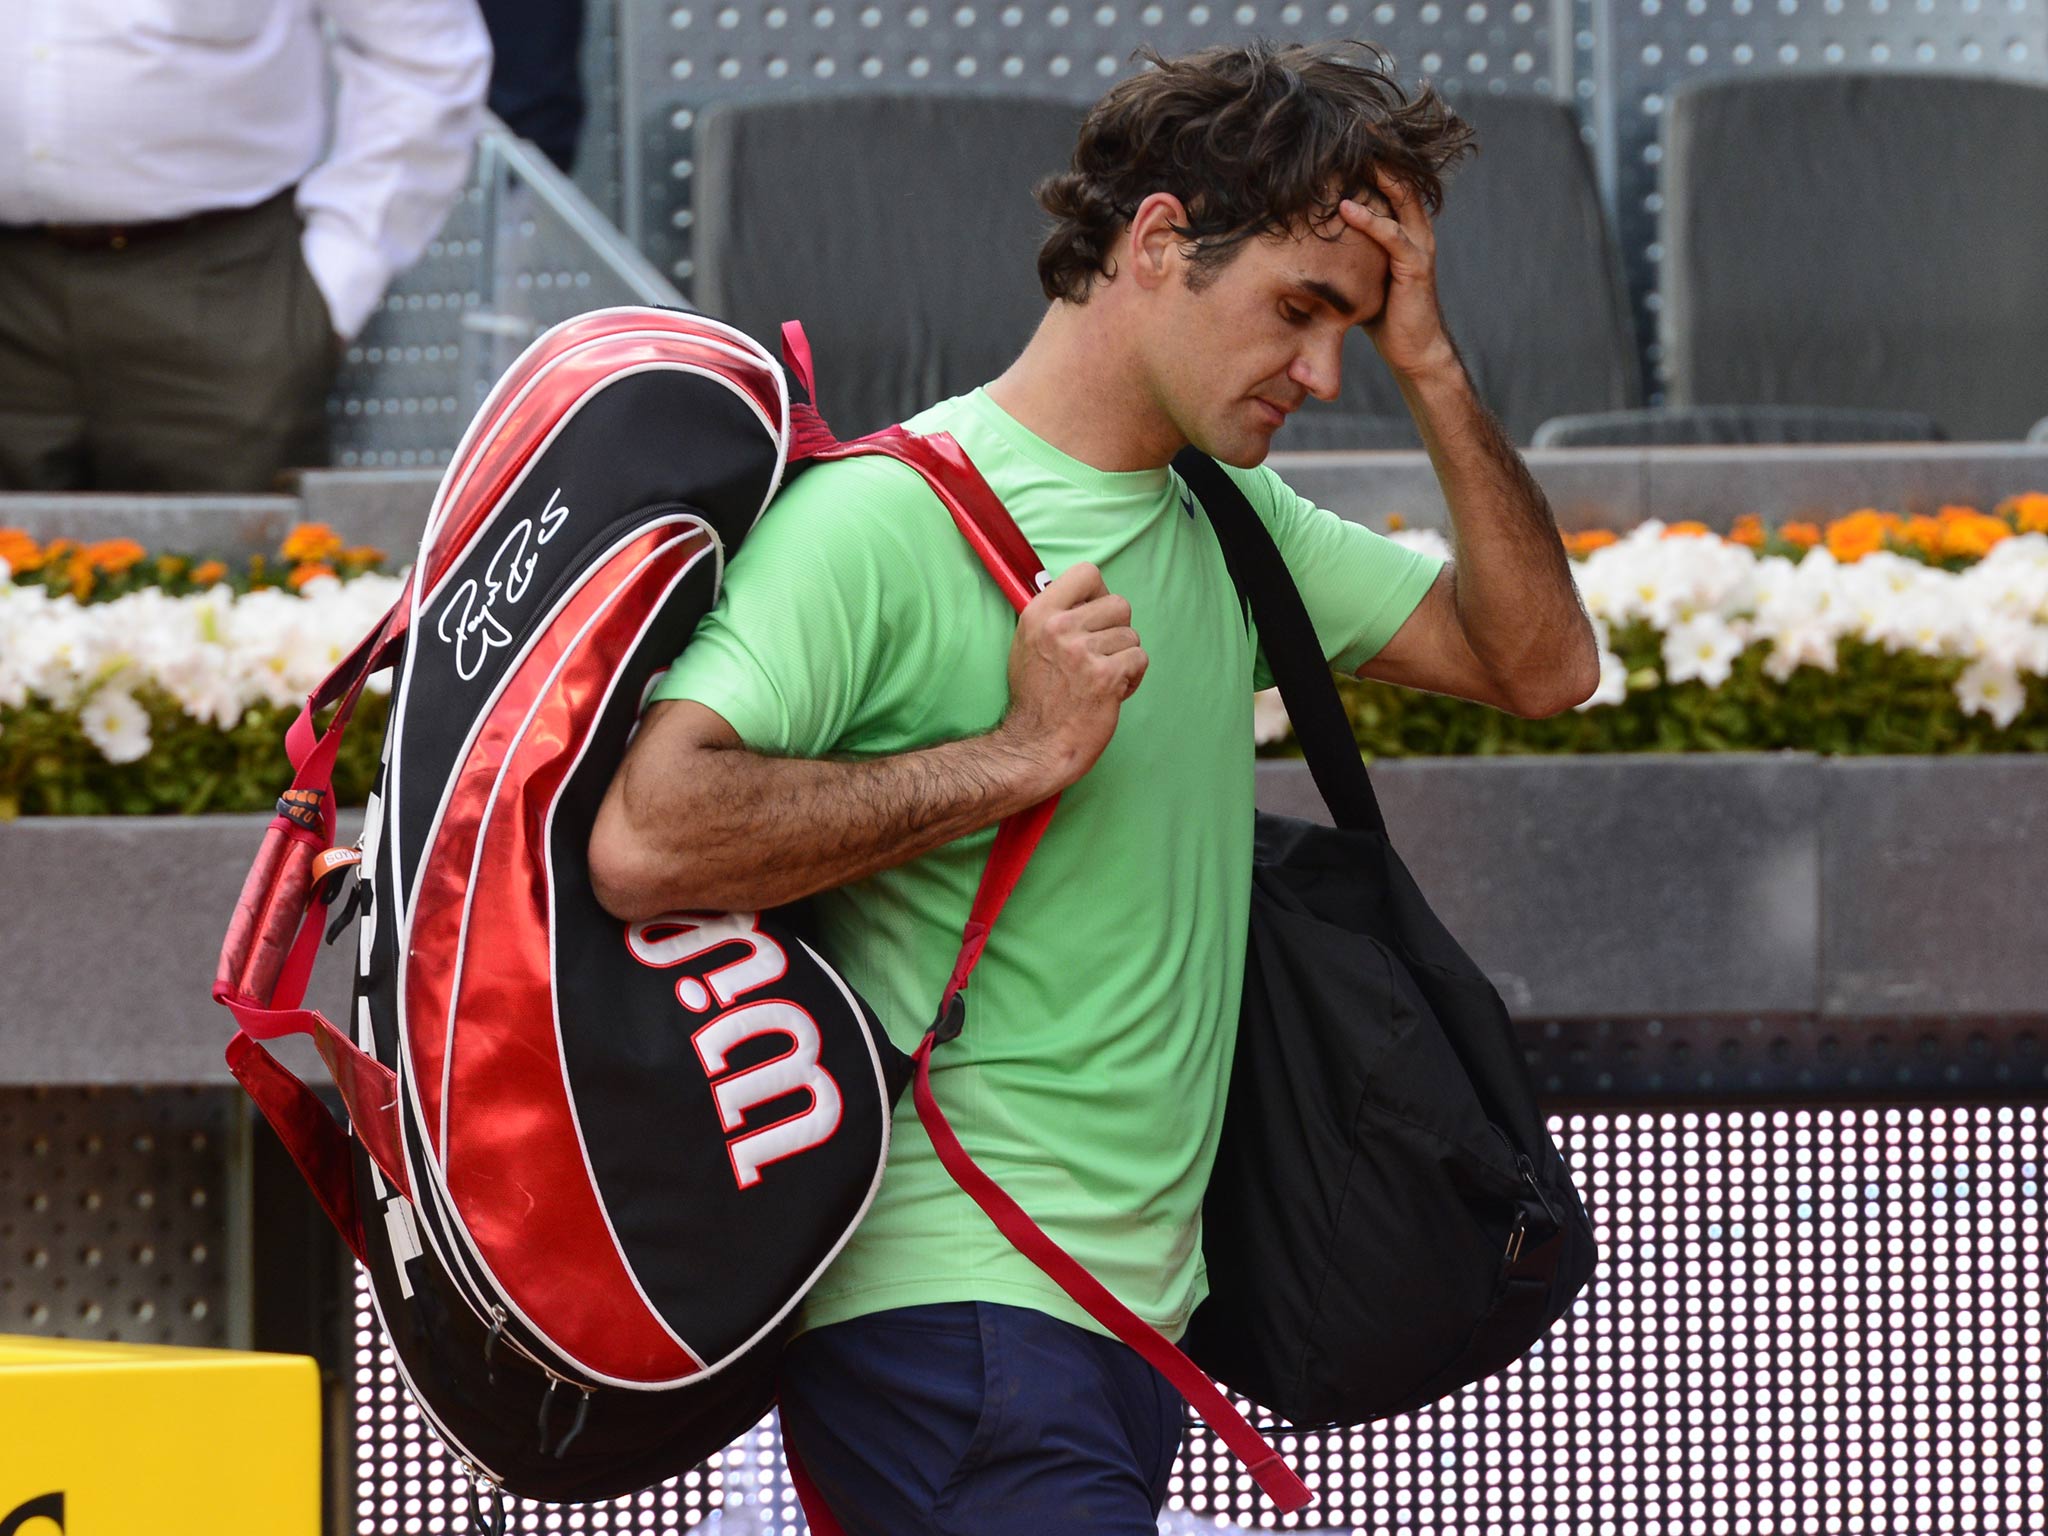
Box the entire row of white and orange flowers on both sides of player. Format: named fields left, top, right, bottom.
left=0, top=496, right=2048, bottom=819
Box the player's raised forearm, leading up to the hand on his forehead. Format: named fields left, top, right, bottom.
left=1401, top=356, right=1599, bottom=709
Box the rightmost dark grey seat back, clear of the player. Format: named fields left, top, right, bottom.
left=1663, top=74, right=2048, bottom=440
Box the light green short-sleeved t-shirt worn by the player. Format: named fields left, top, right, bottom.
left=653, top=389, right=1438, bottom=1337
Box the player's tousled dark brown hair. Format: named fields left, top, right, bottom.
left=1036, top=41, right=1477, bottom=303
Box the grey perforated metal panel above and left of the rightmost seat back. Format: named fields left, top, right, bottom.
left=1579, top=0, right=2048, bottom=393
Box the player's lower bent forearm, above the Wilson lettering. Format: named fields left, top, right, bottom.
left=598, top=731, right=1053, bottom=920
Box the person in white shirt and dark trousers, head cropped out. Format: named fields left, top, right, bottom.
left=0, top=0, right=492, bottom=492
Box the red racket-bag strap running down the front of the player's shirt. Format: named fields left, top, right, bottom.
left=791, top=426, right=1311, bottom=1518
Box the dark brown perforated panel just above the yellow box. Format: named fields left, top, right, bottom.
left=0, top=1087, right=246, bottom=1346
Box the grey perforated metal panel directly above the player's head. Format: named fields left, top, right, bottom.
left=623, top=0, right=1569, bottom=289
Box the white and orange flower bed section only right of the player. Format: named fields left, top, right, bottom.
left=1286, top=496, right=2048, bottom=758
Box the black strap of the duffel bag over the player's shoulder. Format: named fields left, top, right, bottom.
left=1174, top=449, right=1386, bottom=831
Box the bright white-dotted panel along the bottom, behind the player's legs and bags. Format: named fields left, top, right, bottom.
left=356, top=1106, right=2048, bottom=1536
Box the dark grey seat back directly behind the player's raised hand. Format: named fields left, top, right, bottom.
left=1276, top=94, right=1642, bottom=449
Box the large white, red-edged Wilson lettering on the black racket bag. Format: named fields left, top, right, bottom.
left=627, top=911, right=844, bottom=1190
